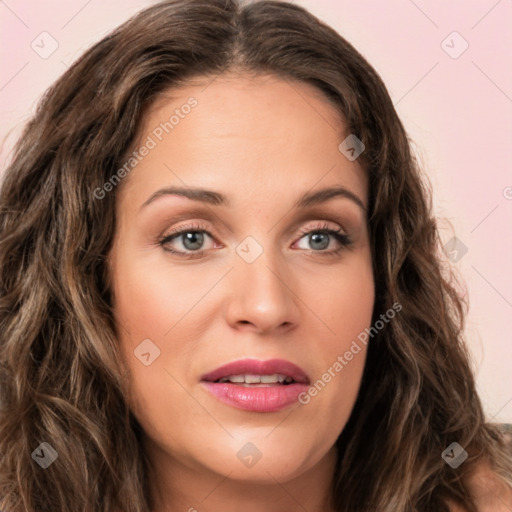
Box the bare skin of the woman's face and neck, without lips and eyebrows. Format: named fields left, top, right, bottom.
left=109, top=74, right=375, bottom=512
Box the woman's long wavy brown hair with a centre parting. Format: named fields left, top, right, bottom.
left=0, top=0, right=512, bottom=512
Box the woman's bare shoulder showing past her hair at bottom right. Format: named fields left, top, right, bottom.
left=448, top=461, right=512, bottom=512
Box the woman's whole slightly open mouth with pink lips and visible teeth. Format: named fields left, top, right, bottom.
left=201, top=359, right=310, bottom=412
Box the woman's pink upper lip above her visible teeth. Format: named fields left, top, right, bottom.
left=201, top=359, right=309, bottom=384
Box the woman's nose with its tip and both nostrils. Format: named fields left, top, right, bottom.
left=226, top=245, right=300, bottom=334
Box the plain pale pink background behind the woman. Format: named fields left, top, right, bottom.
left=0, top=0, right=512, bottom=422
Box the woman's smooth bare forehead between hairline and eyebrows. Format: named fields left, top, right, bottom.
left=118, top=71, right=367, bottom=209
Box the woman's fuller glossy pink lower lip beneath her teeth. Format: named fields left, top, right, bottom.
left=202, top=381, right=308, bottom=412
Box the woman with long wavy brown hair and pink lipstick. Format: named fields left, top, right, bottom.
left=0, top=0, right=512, bottom=512
